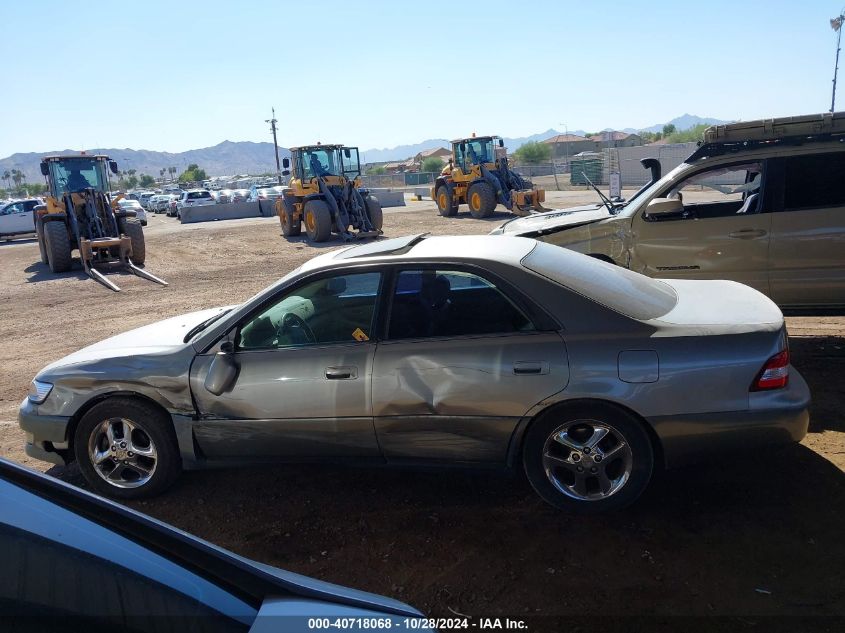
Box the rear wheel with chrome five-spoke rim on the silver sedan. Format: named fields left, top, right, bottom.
left=523, top=403, right=654, bottom=514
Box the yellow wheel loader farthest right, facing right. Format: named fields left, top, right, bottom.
left=431, top=136, right=548, bottom=219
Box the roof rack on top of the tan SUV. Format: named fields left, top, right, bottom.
left=686, top=112, right=845, bottom=162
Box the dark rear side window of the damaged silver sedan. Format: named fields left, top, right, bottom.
left=388, top=269, right=535, bottom=339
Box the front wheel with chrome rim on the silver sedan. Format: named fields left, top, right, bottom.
left=73, top=398, right=182, bottom=499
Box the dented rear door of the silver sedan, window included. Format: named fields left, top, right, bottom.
left=373, top=265, right=569, bottom=463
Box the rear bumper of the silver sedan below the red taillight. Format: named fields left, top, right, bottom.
left=648, top=367, right=811, bottom=468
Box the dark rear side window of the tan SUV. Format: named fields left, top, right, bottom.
left=783, top=152, right=845, bottom=211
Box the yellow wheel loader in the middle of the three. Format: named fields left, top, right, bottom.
left=276, top=143, right=382, bottom=242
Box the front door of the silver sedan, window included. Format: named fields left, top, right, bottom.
left=191, top=272, right=381, bottom=459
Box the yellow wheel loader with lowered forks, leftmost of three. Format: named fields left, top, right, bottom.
left=35, top=152, right=167, bottom=291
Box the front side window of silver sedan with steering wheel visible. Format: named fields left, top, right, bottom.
left=236, top=273, right=381, bottom=350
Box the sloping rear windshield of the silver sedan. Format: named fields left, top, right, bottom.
left=522, top=242, right=678, bottom=321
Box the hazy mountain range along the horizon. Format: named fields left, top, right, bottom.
left=0, top=114, right=727, bottom=181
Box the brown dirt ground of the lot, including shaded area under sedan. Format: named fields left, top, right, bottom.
left=0, top=192, right=845, bottom=631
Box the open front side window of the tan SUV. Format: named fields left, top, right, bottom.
left=662, top=161, right=763, bottom=219
